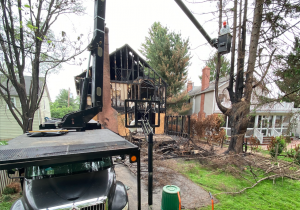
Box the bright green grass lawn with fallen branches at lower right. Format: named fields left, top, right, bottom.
left=179, top=162, right=300, bottom=210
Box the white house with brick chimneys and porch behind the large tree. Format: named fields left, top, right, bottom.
left=187, top=67, right=300, bottom=143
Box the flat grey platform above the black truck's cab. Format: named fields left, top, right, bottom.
left=0, top=129, right=139, bottom=170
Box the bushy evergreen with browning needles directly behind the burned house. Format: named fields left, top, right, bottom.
left=139, top=22, right=191, bottom=113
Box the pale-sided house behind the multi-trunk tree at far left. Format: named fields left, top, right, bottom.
left=0, top=76, right=51, bottom=140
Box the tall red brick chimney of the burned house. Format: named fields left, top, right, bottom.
left=97, top=27, right=118, bottom=133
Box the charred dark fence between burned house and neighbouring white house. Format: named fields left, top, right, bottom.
left=165, top=115, right=191, bottom=138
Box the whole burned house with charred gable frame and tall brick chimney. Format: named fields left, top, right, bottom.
left=75, top=28, right=167, bottom=136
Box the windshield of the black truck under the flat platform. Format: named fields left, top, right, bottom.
left=25, top=157, right=112, bottom=179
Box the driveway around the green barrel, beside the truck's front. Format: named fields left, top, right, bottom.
left=115, top=161, right=214, bottom=210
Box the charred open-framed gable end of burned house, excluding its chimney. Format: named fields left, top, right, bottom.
left=109, top=44, right=166, bottom=112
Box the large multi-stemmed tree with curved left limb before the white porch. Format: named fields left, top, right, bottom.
left=215, top=0, right=263, bottom=153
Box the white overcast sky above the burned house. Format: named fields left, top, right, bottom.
left=47, top=0, right=229, bottom=101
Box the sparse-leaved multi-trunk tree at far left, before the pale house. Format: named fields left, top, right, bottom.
left=0, top=0, right=84, bottom=132
